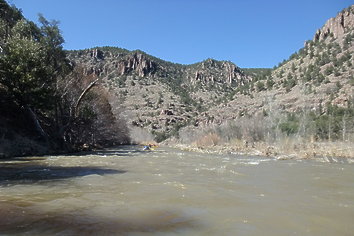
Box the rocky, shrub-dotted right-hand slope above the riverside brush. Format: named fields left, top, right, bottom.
left=206, top=6, right=354, bottom=119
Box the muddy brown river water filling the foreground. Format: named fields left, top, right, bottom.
left=0, top=146, right=354, bottom=235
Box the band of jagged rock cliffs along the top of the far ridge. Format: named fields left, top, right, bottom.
left=69, top=47, right=251, bottom=87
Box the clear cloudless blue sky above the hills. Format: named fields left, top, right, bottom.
left=7, top=0, right=354, bottom=68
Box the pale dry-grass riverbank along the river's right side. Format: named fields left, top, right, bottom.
left=168, top=139, right=354, bottom=160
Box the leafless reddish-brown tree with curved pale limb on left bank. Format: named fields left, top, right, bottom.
left=57, top=66, right=129, bottom=148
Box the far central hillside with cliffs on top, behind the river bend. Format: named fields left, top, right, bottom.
left=68, top=47, right=251, bottom=141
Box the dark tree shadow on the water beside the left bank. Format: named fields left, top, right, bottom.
left=0, top=163, right=126, bottom=186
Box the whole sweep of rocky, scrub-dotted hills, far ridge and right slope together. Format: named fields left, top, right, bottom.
left=68, top=6, right=354, bottom=144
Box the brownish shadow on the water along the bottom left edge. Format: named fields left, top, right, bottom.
left=0, top=203, right=202, bottom=235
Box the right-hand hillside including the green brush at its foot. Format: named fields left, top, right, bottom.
left=192, top=6, right=354, bottom=140
